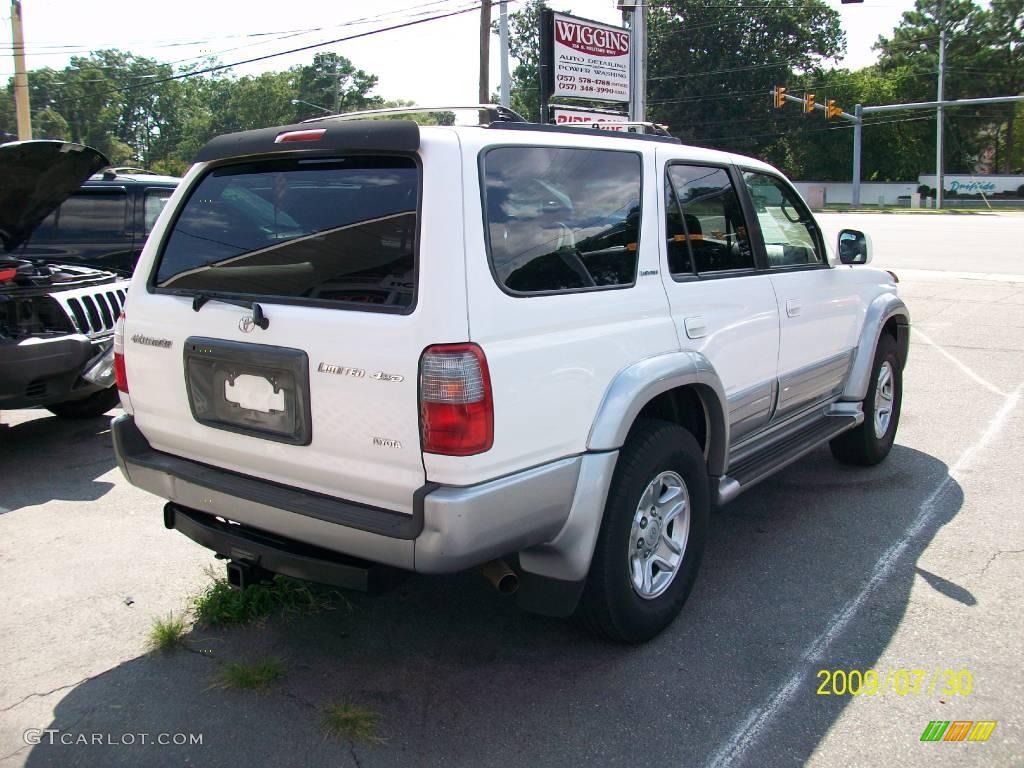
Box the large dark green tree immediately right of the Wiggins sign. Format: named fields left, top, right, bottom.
left=647, top=0, right=846, bottom=165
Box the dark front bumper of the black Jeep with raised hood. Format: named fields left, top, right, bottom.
left=0, top=334, right=110, bottom=410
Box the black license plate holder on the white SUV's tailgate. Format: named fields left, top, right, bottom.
left=184, top=336, right=312, bottom=445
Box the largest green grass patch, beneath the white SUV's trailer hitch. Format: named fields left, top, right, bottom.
left=193, top=575, right=331, bottom=627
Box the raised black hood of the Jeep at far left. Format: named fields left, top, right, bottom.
left=0, top=141, right=111, bottom=253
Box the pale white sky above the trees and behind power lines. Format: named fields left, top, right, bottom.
left=0, top=0, right=913, bottom=105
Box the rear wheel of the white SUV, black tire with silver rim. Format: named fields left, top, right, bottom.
left=577, top=419, right=710, bottom=643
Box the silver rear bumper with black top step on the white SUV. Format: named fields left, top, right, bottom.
left=112, top=414, right=584, bottom=579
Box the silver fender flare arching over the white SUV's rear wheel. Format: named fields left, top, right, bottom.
left=587, top=351, right=729, bottom=476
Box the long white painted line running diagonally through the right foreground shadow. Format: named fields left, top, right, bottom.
left=705, top=386, right=1022, bottom=768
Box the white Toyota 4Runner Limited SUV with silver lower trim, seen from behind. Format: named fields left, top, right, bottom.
left=113, top=110, right=908, bottom=642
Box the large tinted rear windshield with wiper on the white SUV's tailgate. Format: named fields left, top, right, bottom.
left=154, top=156, right=420, bottom=311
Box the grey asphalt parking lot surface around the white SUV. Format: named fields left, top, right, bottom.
left=0, top=214, right=1024, bottom=768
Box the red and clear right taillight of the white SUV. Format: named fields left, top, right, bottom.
left=420, top=344, right=495, bottom=456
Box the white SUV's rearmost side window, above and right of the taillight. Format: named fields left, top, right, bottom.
left=482, top=146, right=641, bottom=295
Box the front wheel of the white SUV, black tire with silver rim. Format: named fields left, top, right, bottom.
left=828, top=334, right=903, bottom=467
